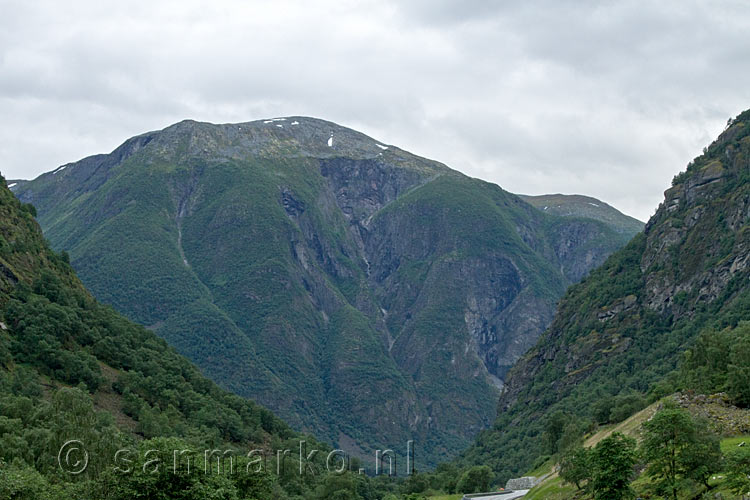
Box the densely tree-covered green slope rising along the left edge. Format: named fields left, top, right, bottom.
left=0, top=171, right=346, bottom=500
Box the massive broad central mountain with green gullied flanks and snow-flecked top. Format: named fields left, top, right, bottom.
left=8, top=117, right=632, bottom=465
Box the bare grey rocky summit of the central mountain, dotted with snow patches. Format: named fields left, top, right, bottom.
left=19, top=116, right=450, bottom=195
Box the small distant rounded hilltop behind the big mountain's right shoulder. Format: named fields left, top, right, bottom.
left=518, top=194, right=645, bottom=236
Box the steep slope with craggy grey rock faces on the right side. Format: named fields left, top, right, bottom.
left=462, top=111, right=750, bottom=478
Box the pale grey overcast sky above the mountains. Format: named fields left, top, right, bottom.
left=0, top=0, right=750, bottom=220
